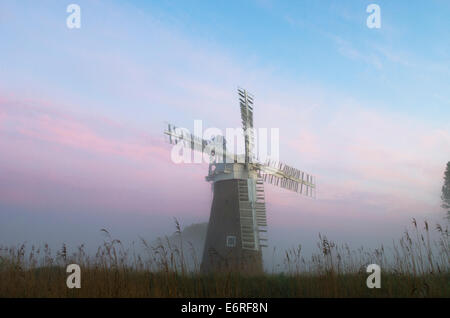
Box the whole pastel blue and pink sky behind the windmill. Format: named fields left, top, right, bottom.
left=0, top=0, right=450, bottom=258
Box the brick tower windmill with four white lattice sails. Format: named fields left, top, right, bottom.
left=164, top=88, right=316, bottom=272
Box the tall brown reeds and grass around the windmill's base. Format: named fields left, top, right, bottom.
left=0, top=220, right=450, bottom=298
